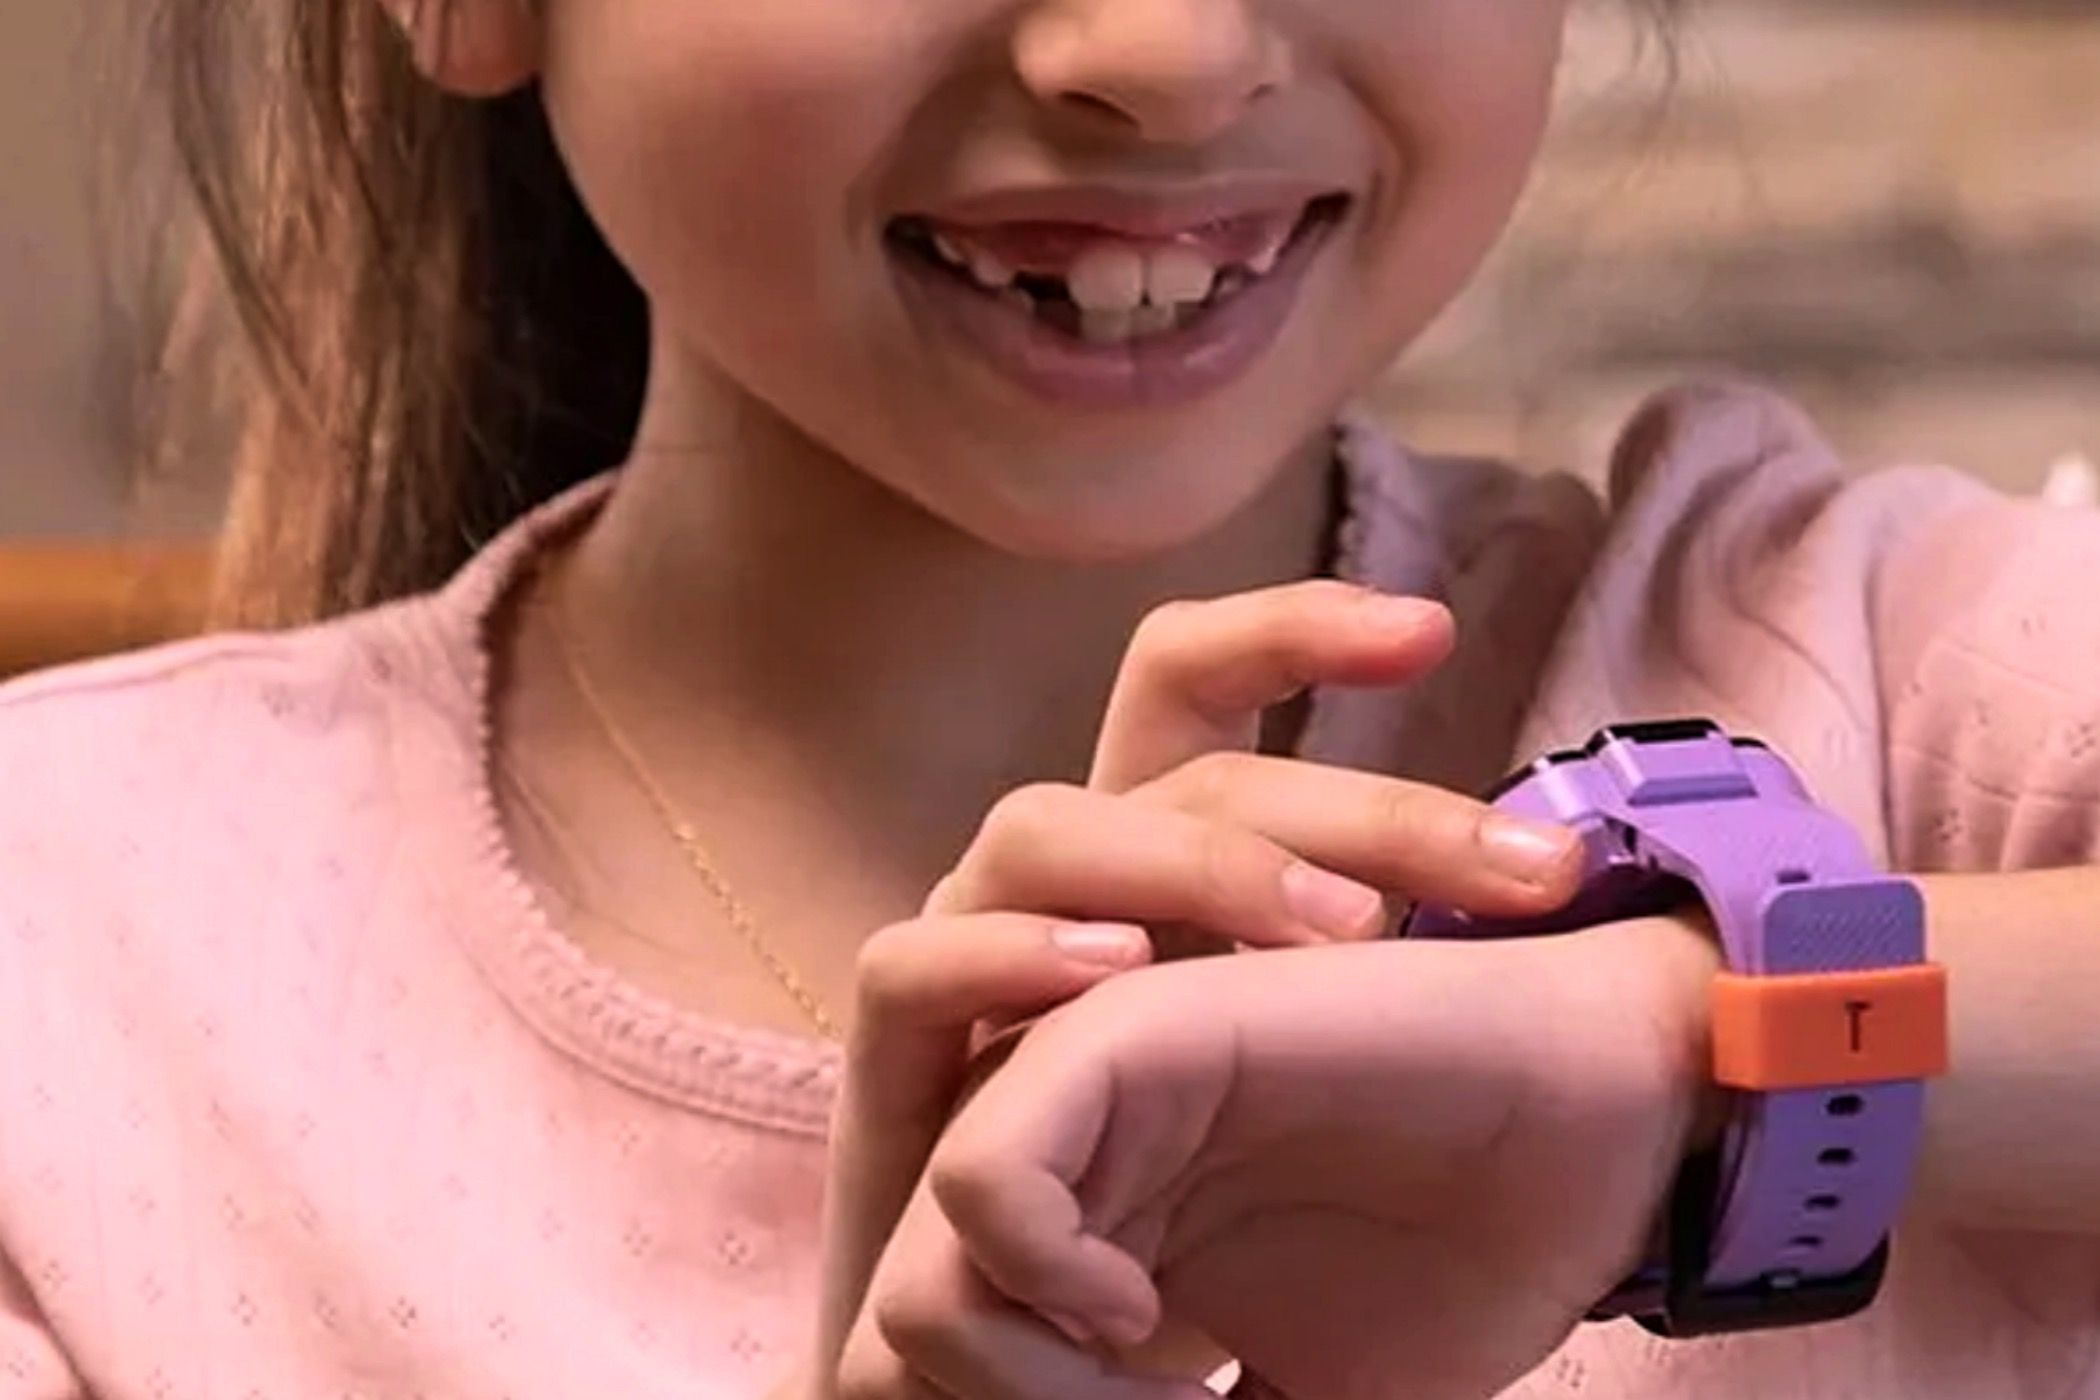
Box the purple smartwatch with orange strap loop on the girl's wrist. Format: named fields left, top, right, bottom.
left=1401, top=720, right=1947, bottom=1337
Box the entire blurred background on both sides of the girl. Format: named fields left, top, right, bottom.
left=0, top=0, right=2100, bottom=674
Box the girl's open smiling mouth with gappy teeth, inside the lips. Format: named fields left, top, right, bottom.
left=884, top=195, right=1350, bottom=348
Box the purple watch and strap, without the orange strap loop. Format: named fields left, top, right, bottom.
left=1407, top=720, right=1926, bottom=1335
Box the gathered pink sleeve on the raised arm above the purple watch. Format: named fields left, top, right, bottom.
left=1525, top=382, right=2100, bottom=873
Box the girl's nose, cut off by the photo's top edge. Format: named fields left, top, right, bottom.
left=1014, top=0, right=1289, bottom=145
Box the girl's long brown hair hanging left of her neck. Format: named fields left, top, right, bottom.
left=149, top=0, right=1682, bottom=628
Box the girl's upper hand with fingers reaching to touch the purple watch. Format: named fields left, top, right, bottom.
left=817, top=581, right=1577, bottom=1396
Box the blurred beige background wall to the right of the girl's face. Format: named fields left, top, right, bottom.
left=1380, top=0, right=2100, bottom=501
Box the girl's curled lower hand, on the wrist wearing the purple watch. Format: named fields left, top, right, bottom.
left=874, top=917, right=1718, bottom=1400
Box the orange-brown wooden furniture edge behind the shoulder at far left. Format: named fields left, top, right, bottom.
left=0, top=542, right=210, bottom=678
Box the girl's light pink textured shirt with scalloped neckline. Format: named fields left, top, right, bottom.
left=0, top=377, right=2100, bottom=1400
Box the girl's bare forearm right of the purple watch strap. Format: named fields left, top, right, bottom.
left=1915, top=867, right=2100, bottom=1234
